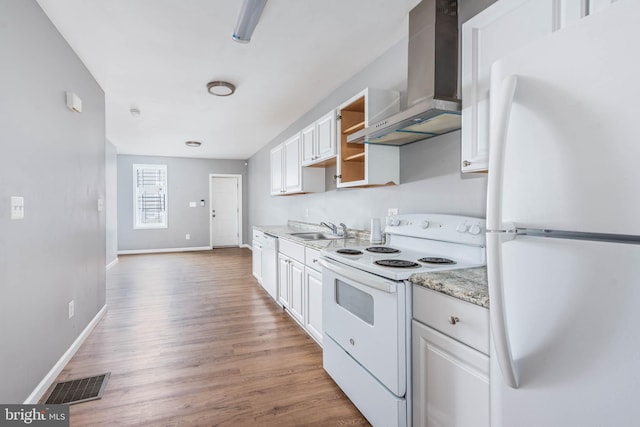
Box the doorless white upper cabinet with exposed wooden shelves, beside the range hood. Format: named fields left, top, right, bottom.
left=336, top=88, right=400, bottom=188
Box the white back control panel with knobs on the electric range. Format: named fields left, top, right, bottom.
left=384, top=214, right=487, bottom=246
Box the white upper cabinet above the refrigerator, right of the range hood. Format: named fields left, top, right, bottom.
left=461, top=0, right=614, bottom=172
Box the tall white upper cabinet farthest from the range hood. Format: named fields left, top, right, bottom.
left=271, top=132, right=324, bottom=195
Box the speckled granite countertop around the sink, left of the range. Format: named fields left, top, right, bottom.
left=253, top=221, right=369, bottom=250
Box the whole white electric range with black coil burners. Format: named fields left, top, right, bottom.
left=321, top=214, right=486, bottom=426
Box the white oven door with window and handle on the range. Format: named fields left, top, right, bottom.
left=322, top=258, right=407, bottom=397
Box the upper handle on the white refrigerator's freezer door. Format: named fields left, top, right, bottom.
left=487, top=73, right=518, bottom=234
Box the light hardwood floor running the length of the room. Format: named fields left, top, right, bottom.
left=50, top=248, right=368, bottom=426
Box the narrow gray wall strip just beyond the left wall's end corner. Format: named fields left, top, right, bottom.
left=105, top=142, right=118, bottom=265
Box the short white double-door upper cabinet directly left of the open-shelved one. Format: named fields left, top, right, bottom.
left=301, top=110, right=337, bottom=167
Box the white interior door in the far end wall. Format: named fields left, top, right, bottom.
left=209, top=175, right=242, bottom=247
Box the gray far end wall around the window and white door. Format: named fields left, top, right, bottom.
left=118, top=155, right=250, bottom=251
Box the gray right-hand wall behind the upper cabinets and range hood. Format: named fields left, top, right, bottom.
left=249, top=39, right=486, bottom=236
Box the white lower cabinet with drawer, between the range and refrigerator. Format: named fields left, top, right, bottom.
left=412, top=286, right=490, bottom=427
